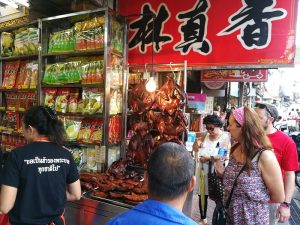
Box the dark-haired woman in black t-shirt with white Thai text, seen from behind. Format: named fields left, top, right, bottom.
left=0, top=106, right=81, bottom=225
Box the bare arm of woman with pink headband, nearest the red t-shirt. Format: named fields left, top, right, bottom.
left=259, top=150, right=284, bottom=203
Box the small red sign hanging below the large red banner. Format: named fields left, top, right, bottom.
left=201, top=69, right=268, bottom=82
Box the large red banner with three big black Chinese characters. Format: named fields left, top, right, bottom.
left=120, top=0, right=297, bottom=68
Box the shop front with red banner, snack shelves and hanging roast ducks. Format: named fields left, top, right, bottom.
left=0, top=0, right=297, bottom=225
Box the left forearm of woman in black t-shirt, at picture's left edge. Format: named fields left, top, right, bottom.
left=0, top=185, right=18, bottom=214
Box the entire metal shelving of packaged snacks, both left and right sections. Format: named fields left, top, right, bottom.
left=0, top=8, right=127, bottom=172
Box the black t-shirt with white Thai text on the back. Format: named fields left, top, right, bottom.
left=2, top=142, right=79, bottom=225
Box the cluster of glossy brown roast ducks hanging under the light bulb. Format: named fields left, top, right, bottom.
left=126, top=77, right=187, bottom=168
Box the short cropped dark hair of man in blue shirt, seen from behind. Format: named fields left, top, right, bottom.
left=148, top=142, right=194, bottom=200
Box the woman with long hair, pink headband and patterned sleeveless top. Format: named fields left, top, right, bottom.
left=215, top=106, right=284, bottom=225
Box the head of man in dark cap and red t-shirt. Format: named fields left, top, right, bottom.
left=255, top=103, right=278, bottom=130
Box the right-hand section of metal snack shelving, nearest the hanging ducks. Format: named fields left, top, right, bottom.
left=40, top=9, right=127, bottom=172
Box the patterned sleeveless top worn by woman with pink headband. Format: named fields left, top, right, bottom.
left=223, top=156, right=270, bottom=225
